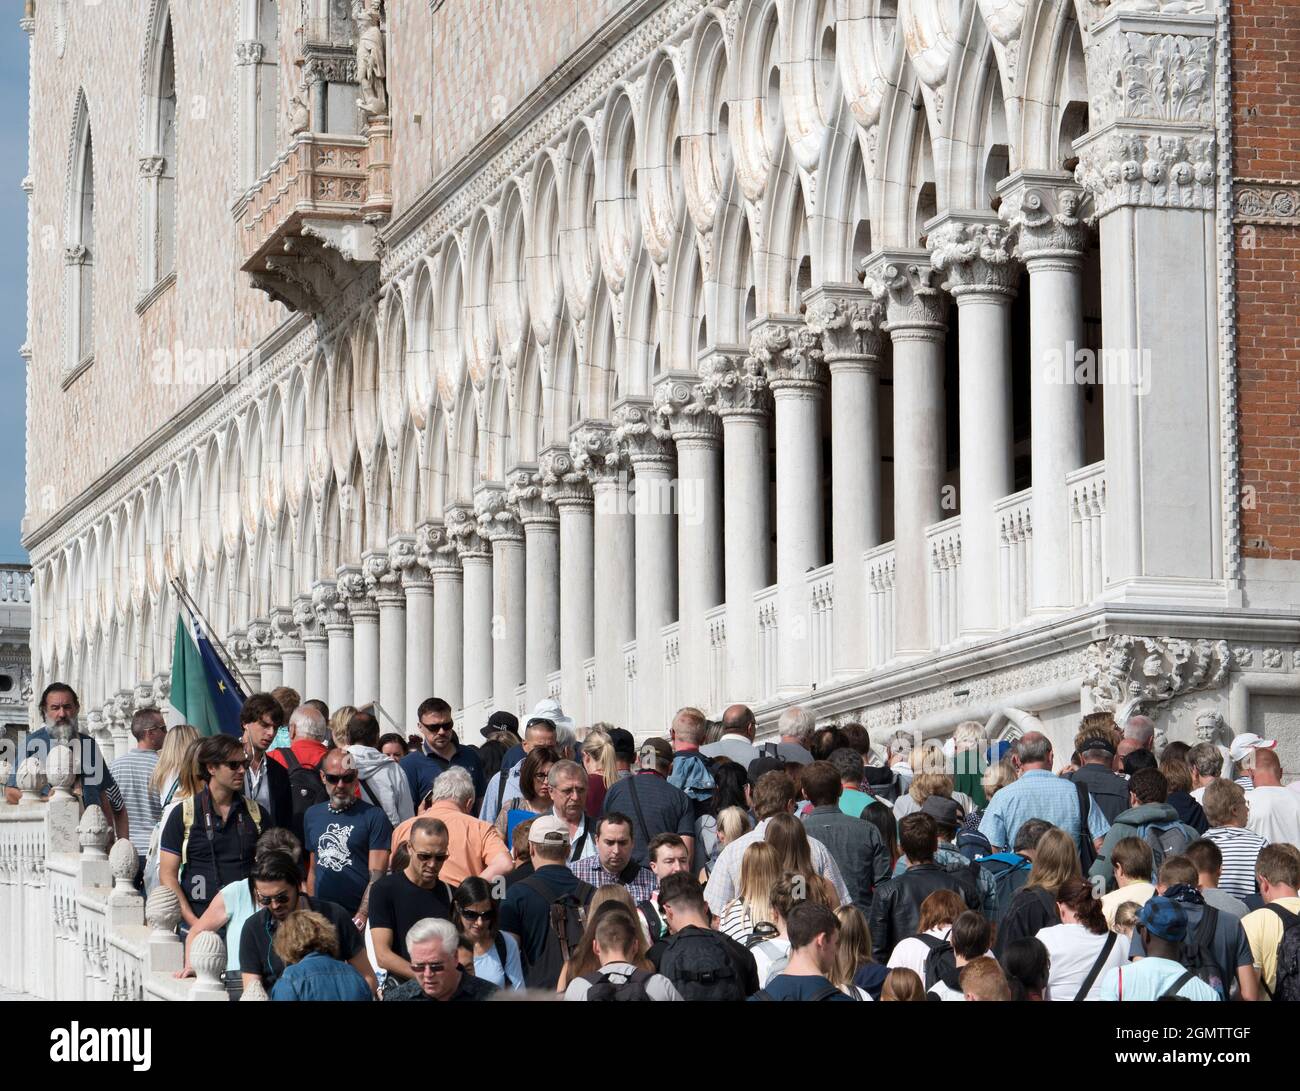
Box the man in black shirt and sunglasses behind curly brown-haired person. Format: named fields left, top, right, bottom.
left=239, top=852, right=378, bottom=996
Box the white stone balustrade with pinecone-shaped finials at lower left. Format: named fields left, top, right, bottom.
left=0, top=748, right=226, bottom=1001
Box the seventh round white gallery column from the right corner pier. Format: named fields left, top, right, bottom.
left=654, top=371, right=723, bottom=731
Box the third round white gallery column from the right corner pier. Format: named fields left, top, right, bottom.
left=865, top=250, right=948, bottom=657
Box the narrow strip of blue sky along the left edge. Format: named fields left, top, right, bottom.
left=0, top=26, right=27, bottom=560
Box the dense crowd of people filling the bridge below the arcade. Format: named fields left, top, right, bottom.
left=7, top=684, right=1300, bottom=1001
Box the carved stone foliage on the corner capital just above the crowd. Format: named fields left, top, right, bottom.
left=1084, top=636, right=1232, bottom=713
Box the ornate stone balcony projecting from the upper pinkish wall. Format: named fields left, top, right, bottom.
left=237, top=126, right=393, bottom=315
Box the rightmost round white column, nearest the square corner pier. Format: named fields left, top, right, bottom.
left=997, top=170, right=1100, bottom=610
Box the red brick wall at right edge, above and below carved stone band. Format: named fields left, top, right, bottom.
left=1232, top=0, right=1300, bottom=560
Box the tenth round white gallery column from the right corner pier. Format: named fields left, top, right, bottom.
left=540, top=446, right=595, bottom=718
